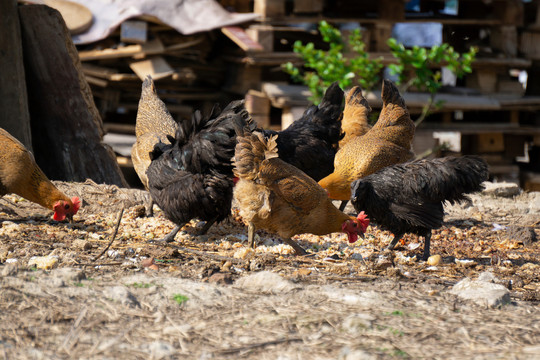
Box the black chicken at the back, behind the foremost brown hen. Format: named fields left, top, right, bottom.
left=261, top=82, right=343, bottom=181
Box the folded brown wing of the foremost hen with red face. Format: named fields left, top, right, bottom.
left=258, top=158, right=328, bottom=213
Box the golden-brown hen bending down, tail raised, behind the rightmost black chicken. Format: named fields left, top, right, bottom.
left=319, top=80, right=415, bottom=200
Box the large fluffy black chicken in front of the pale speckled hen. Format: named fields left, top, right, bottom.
left=146, top=101, right=251, bottom=242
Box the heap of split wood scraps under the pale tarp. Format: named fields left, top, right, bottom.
left=78, top=17, right=230, bottom=133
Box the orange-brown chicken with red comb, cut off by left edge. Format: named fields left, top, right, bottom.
left=0, top=128, right=81, bottom=221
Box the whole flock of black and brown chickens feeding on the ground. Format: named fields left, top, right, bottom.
left=0, top=77, right=488, bottom=260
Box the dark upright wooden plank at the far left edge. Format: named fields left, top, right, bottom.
left=0, top=0, right=32, bottom=150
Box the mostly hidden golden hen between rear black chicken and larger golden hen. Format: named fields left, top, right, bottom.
left=339, top=86, right=371, bottom=148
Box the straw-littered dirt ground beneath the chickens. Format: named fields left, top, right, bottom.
left=0, top=182, right=540, bottom=360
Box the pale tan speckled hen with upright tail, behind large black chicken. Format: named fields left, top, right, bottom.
left=131, top=76, right=178, bottom=189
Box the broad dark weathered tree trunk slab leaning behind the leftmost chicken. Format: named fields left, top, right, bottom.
left=19, top=5, right=127, bottom=186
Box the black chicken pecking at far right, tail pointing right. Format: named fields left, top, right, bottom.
left=351, top=155, right=488, bottom=260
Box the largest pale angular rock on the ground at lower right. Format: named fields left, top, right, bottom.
left=450, top=272, right=510, bottom=307
